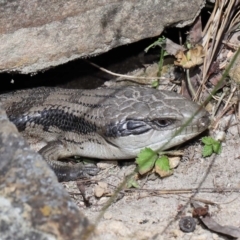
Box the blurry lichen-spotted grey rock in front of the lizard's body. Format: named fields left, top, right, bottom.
left=0, top=108, right=90, bottom=240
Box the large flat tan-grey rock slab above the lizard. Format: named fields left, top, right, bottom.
left=0, top=0, right=205, bottom=73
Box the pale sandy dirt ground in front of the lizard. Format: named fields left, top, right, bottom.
left=64, top=113, right=240, bottom=240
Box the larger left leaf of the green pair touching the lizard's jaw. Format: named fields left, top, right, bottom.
left=136, top=148, right=158, bottom=174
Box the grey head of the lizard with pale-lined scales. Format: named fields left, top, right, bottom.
left=100, top=87, right=210, bottom=158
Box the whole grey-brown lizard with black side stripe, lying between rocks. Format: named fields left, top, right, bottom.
left=0, top=86, right=210, bottom=181
